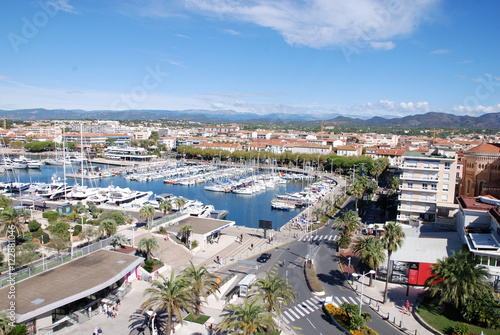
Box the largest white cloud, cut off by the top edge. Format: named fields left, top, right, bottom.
left=184, top=0, right=440, bottom=49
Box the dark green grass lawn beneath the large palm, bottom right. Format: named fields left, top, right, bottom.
left=418, top=299, right=500, bottom=335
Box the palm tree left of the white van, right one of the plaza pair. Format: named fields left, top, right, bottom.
left=182, top=262, right=219, bottom=319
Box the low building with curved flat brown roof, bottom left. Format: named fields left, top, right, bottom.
left=0, top=249, right=144, bottom=335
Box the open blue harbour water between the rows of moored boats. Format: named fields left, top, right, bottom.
left=0, top=165, right=307, bottom=229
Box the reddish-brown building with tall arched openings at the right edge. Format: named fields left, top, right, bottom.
left=459, top=143, right=500, bottom=198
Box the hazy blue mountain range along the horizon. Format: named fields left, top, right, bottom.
left=0, top=108, right=500, bottom=129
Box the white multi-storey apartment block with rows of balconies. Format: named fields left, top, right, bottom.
left=398, top=149, right=458, bottom=223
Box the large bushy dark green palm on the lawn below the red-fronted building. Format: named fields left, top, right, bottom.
left=425, top=250, right=492, bottom=308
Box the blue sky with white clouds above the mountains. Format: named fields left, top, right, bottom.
left=0, top=0, right=500, bottom=117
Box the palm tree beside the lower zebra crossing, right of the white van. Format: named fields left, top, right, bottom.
left=251, top=271, right=297, bottom=317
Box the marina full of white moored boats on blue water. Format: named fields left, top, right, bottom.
left=0, top=162, right=328, bottom=229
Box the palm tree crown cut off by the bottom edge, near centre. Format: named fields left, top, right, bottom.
left=217, top=299, right=276, bottom=335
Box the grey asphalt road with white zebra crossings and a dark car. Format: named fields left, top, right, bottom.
left=250, top=198, right=401, bottom=335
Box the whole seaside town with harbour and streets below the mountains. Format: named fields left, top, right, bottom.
left=0, top=119, right=500, bottom=334
